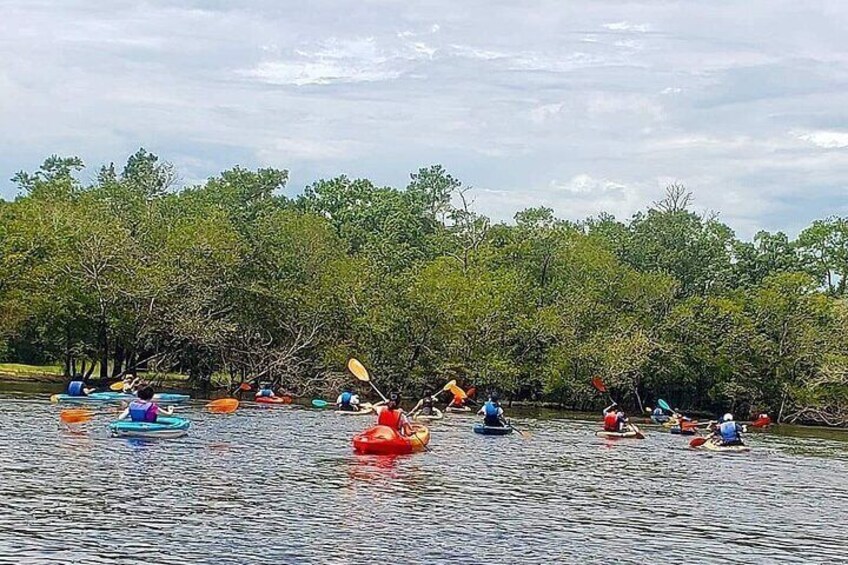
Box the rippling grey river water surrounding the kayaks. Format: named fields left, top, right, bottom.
left=0, top=393, right=848, bottom=565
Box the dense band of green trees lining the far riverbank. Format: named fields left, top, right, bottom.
left=0, top=150, right=848, bottom=425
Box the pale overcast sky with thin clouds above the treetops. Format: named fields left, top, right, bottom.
left=0, top=0, right=848, bottom=237
